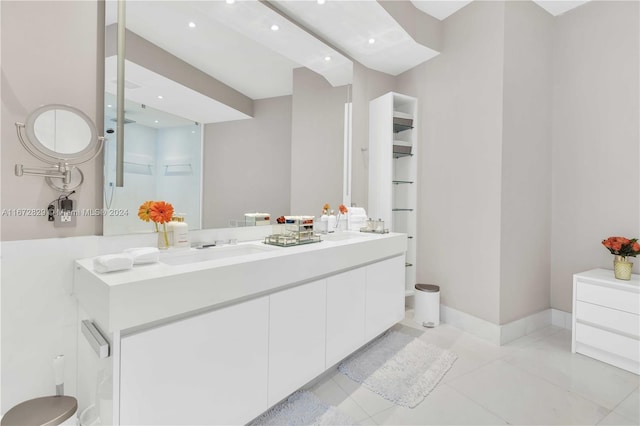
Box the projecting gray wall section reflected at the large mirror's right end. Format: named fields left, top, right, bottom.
left=290, top=68, right=348, bottom=216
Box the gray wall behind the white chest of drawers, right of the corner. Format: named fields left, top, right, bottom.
left=551, top=1, right=640, bottom=311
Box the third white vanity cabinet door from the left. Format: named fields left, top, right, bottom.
left=326, top=268, right=366, bottom=368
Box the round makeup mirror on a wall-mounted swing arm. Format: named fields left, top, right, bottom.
left=25, top=104, right=101, bottom=164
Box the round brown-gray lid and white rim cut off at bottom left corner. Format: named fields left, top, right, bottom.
left=0, top=395, right=78, bottom=426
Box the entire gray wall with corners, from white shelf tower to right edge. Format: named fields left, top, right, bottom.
left=397, top=1, right=640, bottom=324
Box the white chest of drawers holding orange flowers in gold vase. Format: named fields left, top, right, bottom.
left=571, top=269, right=640, bottom=374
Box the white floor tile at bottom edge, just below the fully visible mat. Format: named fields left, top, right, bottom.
left=373, top=384, right=507, bottom=425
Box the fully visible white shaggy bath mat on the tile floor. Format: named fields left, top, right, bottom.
left=338, top=331, right=458, bottom=408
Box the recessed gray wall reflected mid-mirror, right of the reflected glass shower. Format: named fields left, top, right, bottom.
left=202, top=96, right=291, bottom=229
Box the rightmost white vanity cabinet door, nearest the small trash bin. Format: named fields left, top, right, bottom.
left=365, top=255, right=405, bottom=340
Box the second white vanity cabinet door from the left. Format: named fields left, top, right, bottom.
left=268, top=280, right=326, bottom=405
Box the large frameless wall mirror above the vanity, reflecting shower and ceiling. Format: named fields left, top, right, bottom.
left=104, top=1, right=352, bottom=235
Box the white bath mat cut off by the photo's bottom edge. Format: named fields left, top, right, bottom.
left=249, top=391, right=357, bottom=426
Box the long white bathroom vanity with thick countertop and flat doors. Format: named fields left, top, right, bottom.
left=74, top=232, right=407, bottom=425
